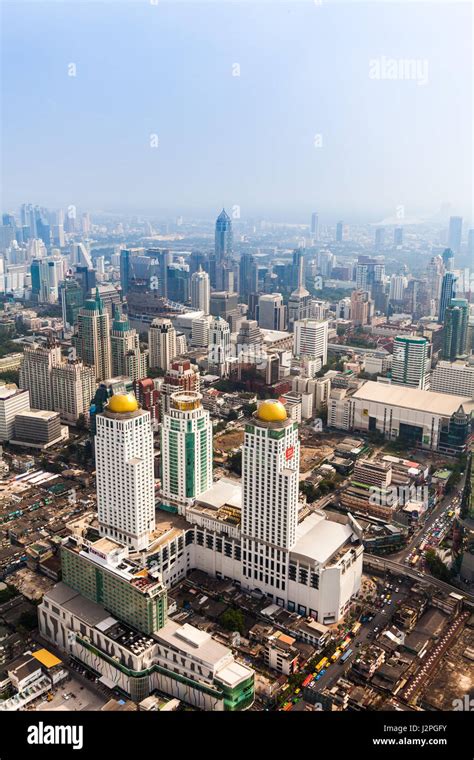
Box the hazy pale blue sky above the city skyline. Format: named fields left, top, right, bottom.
left=2, top=0, right=473, bottom=221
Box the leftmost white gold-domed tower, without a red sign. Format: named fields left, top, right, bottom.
left=95, top=393, right=155, bottom=551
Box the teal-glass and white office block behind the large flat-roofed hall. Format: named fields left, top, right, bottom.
left=392, top=335, right=430, bottom=391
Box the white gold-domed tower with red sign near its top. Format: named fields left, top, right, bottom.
left=242, top=401, right=300, bottom=604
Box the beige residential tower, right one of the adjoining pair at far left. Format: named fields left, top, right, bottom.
left=51, top=359, right=96, bottom=425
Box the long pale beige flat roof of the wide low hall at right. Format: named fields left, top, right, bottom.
left=352, top=380, right=474, bottom=417
